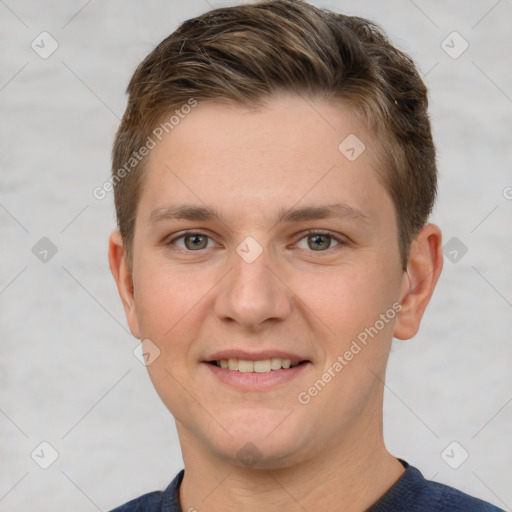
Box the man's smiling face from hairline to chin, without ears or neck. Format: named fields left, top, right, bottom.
left=114, top=96, right=414, bottom=468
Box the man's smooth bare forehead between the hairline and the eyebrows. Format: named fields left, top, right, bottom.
left=140, top=95, right=390, bottom=228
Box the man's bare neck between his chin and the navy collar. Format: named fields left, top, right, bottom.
left=178, top=410, right=404, bottom=512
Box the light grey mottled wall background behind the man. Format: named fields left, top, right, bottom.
left=0, top=0, right=512, bottom=512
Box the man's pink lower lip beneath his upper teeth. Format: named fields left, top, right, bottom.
left=203, top=363, right=310, bottom=391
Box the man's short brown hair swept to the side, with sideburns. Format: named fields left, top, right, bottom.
left=112, top=0, right=437, bottom=269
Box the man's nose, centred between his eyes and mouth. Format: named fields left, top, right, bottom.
left=215, top=240, right=293, bottom=331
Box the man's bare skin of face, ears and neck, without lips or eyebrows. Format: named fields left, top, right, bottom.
left=109, top=95, right=442, bottom=512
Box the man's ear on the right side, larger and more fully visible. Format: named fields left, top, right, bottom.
left=393, top=224, right=443, bottom=340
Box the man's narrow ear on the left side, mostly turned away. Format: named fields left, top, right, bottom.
left=108, top=231, right=140, bottom=339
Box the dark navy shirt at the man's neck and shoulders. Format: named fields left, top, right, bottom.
left=110, top=459, right=504, bottom=512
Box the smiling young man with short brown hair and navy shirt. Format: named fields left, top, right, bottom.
left=109, top=0, right=499, bottom=512
